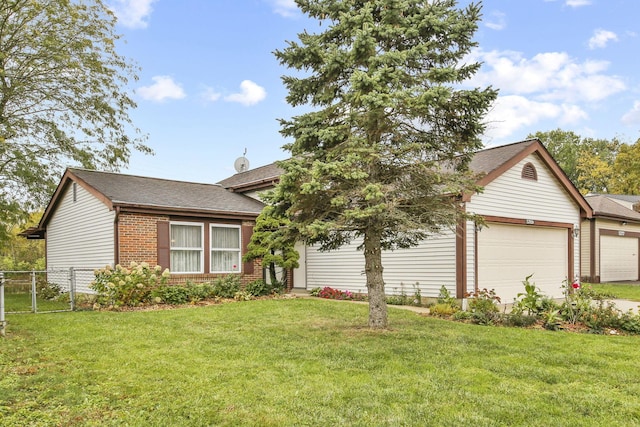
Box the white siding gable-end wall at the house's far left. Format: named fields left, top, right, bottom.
left=46, top=185, right=115, bottom=292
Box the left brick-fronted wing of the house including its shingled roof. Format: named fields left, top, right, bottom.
left=32, top=168, right=264, bottom=291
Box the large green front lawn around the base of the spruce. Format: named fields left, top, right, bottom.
left=0, top=299, right=640, bottom=426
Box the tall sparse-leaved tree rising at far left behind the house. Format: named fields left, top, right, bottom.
left=0, top=0, right=150, bottom=246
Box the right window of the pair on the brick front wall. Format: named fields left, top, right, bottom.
left=211, top=224, right=241, bottom=273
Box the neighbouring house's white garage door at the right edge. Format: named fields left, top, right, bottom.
left=600, top=236, right=638, bottom=282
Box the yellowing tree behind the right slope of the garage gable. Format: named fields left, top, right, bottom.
left=529, top=129, right=620, bottom=194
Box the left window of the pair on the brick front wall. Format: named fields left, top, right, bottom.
left=170, top=222, right=204, bottom=273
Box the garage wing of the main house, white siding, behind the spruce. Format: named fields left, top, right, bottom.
left=219, top=139, right=592, bottom=302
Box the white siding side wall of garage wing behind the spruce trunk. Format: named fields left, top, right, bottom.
left=305, top=232, right=456, bottom=297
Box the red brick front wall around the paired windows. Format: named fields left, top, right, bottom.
left=118, top=212, right=262, bottom=284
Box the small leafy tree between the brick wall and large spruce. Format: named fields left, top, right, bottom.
left=243, top=206, right=300, bottom=288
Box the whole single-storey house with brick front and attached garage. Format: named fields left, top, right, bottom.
left=33, top=139, right=593, bottom=302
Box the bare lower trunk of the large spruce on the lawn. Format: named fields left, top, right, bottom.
left=364, top=230, right=387, bottom=329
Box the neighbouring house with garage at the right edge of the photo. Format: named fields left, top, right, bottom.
left=581, top=194, right=640, bottom=283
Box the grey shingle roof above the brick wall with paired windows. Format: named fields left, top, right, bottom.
left=69, top=168, right=264, bottom=215
